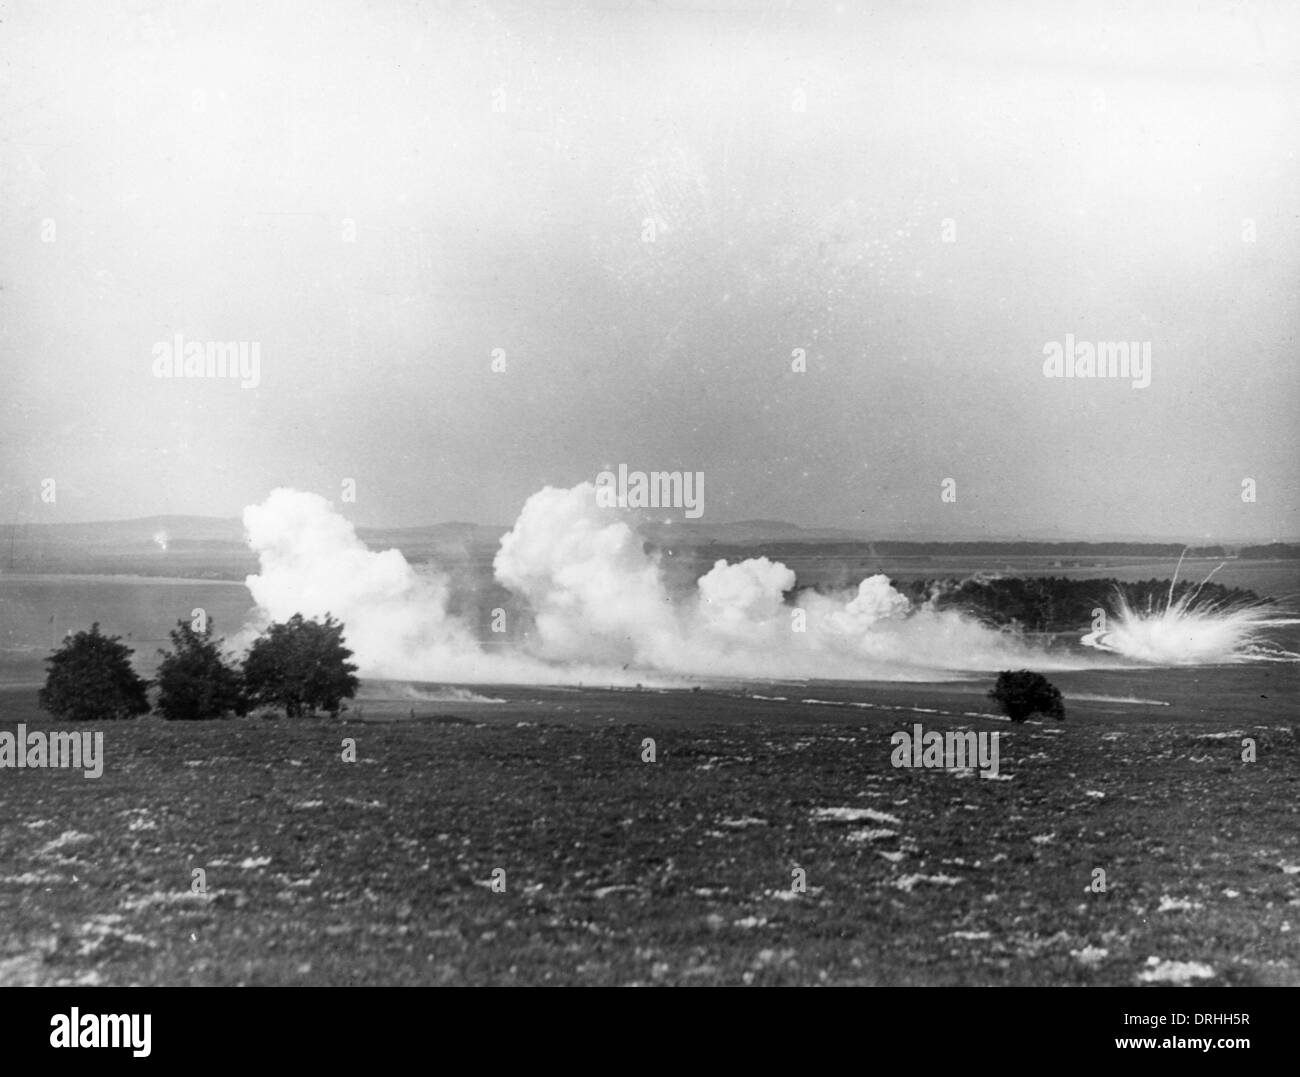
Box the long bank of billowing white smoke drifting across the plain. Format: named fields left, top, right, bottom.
left=244, top=483, right=1097, bottom=683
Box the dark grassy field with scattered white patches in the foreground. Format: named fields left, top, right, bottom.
left=0, top=670, right=1300, bottom=985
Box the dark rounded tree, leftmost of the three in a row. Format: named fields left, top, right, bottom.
left=36, top=620, right=150, bottom=723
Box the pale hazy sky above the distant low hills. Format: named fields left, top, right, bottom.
left=0, top=0, right=1300, bottom=540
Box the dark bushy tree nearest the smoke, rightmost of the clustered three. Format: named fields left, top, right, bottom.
left=244, top=614, right=358, bottom=718
